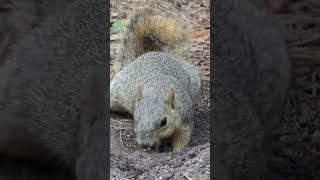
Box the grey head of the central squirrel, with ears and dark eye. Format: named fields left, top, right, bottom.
left=134, top=85, right=182, bottom=148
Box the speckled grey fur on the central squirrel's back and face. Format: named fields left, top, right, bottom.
left=110, top=52, right=201, bottom=150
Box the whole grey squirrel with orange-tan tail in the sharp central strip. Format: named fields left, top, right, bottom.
left=110, top=9, right=201, bottom=152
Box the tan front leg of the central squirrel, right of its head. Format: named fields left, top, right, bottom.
left=171, top=122, right=193, bottom=152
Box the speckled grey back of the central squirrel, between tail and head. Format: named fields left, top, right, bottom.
left=110, top=52, right=200, bottom=113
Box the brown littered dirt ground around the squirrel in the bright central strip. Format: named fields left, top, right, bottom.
left=110, top=0, right=210, bottom=180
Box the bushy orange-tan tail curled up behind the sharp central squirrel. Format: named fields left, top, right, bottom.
left=118, top=8, right=190, bottom=67
